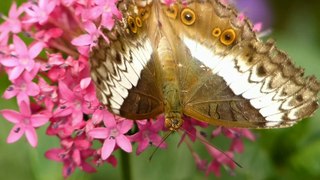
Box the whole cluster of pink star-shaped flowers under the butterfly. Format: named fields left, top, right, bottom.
left=0, top=0, right=254, bottom=177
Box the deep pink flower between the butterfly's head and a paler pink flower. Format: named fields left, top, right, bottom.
left=130, top=120, right=167, bottom=155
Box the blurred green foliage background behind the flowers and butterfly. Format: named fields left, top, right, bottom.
left=0, top=0, right=320, bottom=180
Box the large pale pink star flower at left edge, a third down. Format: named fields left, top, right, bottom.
left=0, top=36, right=43, bottom=80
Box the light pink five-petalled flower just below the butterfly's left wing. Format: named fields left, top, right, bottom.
left=88, top=120, right=133, bottom=160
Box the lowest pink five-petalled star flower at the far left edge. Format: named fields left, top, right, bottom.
left=0, top=101, right=50, bottom=147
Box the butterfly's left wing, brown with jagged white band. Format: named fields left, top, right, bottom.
left=90, top=2, right=163, bottom=119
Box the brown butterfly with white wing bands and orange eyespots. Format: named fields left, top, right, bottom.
left=90, top=0, right=320, bottom=131
